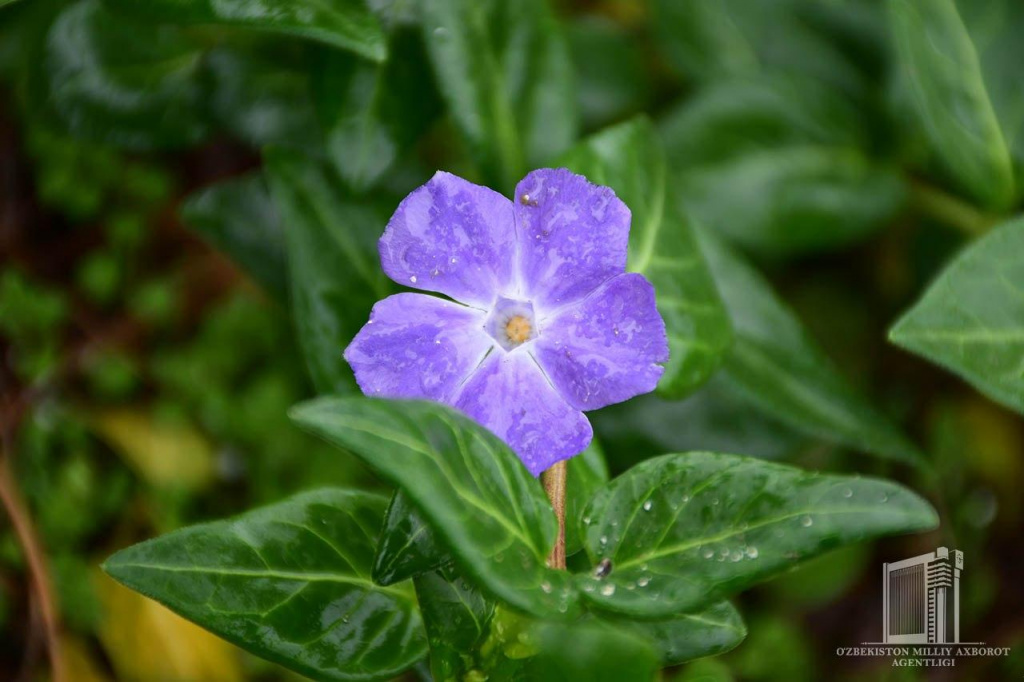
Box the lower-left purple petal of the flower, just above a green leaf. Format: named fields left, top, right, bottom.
left=345, top=294, right=495, bottom=401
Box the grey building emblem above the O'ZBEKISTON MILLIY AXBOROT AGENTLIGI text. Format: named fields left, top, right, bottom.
left=882, top=547, right=964, bottom=644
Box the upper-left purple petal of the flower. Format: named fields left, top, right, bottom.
left=379, top=171, right=515, bottom=306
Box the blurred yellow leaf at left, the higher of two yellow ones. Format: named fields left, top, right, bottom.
left=91, top=409, right=215, bottom=491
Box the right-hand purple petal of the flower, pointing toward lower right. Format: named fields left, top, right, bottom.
left=531, top=273, right=669, bottom=410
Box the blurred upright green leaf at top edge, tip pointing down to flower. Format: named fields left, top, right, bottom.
left=422, top=0, right=578, bottom=191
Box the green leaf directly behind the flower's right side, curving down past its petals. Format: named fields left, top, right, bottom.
left=561, top=119, right=732, bottom=397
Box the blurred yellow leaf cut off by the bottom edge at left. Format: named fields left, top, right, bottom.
left=94, top=573, right=243, bottom=682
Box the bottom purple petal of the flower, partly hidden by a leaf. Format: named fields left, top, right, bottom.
left=455, top=350, right=594, bottom=476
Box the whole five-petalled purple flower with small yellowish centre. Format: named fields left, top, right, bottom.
left=345, top=169, right=669, bottom=475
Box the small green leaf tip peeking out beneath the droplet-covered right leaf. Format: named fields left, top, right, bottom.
left=600, top=601, right=746, bottom=666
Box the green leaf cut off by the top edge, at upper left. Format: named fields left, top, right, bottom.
left=105, top=0, right=387, bottom=61
